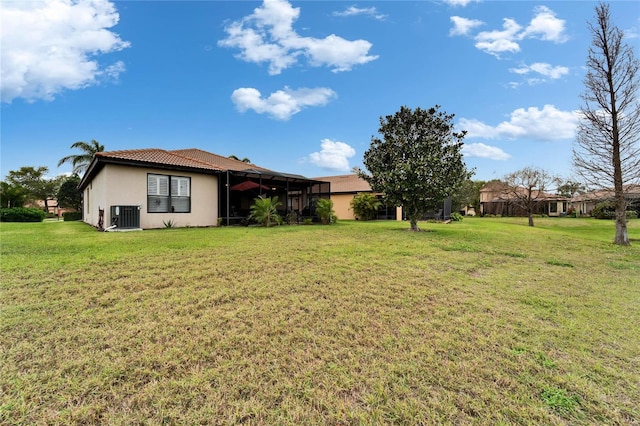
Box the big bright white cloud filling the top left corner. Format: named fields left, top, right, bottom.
left=0, top=0, right=130, bottom=102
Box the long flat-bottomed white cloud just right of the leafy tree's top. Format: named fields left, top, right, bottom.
left=458, top=105, right=579, bottom=141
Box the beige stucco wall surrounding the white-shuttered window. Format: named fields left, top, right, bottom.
left=84, top=164, right=218, bottom=229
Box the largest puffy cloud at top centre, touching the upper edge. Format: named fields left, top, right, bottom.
left=218, top=0, right=378, bottom=75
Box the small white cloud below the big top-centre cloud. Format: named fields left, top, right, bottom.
left=231, top=86, right=337, bottom=121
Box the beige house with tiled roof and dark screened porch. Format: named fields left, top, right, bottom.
left=79, top=148, right=330, bottom=229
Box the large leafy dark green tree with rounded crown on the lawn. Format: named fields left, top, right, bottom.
left=358, top=105, right=473, bottom=231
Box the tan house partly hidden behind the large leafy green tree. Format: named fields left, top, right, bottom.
left=314, top=174, right=402, bottom=220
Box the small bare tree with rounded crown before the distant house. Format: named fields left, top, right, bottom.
left=501, top=167, right=554, bottom=226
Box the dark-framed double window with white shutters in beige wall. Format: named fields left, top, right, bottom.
left=147, top=174, right=191, bottom=213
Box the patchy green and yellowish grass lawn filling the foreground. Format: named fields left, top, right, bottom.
left=0, top=218, right=640, bottom=425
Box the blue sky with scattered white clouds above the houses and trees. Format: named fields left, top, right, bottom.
left=0, top=0, right=640, bottom=180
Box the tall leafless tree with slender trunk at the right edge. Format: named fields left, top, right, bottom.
left=573, top=4, right=640, bottom=245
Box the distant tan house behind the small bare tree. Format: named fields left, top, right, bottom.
left=480, top=180, right=569, bottom=216
